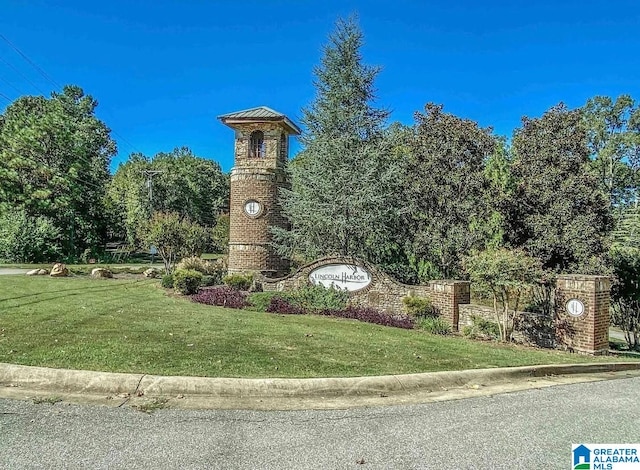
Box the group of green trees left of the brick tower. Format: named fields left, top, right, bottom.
left=0, top=86, right=229, bottom=263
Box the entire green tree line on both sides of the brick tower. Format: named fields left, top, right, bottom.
left=0, top=19, right=640, bottom=341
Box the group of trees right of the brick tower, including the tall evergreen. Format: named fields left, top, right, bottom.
left=274, top=19, right=640, bottom=347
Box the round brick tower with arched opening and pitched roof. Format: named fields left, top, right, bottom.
left=218, top=106, right=300, bottom=277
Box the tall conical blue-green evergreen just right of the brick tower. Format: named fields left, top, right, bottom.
left=274, top=19, right=398, bottom=263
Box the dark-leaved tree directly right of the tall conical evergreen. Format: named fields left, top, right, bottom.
left=403, top=103, right=496, bottom=278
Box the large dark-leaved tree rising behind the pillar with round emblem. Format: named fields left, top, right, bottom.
left=506, top=104, right=613, bottom=274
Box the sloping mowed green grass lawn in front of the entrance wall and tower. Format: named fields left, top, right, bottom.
left=0, top=276, right=632, bottom=377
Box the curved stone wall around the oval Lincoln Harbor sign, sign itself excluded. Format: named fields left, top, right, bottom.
left=261, top=257, right=470, bottom=330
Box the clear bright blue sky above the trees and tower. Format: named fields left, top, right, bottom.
left=0, top=0, right=640, bottom=171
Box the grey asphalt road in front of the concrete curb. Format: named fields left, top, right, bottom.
left=0, top=378, right=640, bottom=469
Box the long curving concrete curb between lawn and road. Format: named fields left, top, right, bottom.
left=0, top=362, right=640, bottom=398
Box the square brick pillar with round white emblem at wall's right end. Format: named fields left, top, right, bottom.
left=555, top=275, right=611, bottom=354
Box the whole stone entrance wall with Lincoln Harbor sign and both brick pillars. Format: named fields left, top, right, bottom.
left=260, top=257, right=610, bottom=354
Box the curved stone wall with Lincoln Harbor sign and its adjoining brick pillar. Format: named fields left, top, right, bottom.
left=261, top=257, right=470, bottom=330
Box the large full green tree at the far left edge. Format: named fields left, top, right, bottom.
left=0, top=86, right=116, bottom=255
